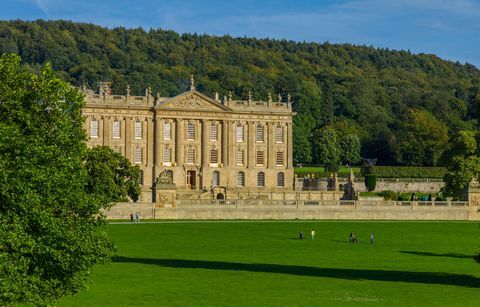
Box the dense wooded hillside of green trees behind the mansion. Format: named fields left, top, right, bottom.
left=0, top=20, right=480, bottom=166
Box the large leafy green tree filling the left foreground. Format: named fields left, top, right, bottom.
left=0, top=55, right=113, bottom=305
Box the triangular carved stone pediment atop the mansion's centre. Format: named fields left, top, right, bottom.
left=156, top=91, right=231, bottom=111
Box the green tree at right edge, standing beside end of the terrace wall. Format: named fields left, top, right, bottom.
left=443, top=131, right=480, bottom=199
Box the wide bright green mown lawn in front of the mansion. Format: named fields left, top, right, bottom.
left=58, top=221, right=480, bottom=306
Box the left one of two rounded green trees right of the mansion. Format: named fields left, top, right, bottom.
left=313, top=127, right=340, bottom=172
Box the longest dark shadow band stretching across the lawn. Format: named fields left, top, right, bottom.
left=113, top=256, right=480, bottom=287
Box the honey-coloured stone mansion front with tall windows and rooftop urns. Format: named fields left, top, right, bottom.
left=83, top=78, right=294, bottom=202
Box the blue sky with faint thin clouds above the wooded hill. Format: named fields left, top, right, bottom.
left=0, top=0, right=480, bottom=67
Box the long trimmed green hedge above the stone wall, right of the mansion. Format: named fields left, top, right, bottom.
left=364, top=166, right=446, bottom=178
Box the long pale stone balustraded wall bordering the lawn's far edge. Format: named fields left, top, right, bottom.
left=107, top=200, right=480, bottom=221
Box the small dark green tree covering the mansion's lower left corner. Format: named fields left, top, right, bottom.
left=85, top=146, right=141, bottom=202
